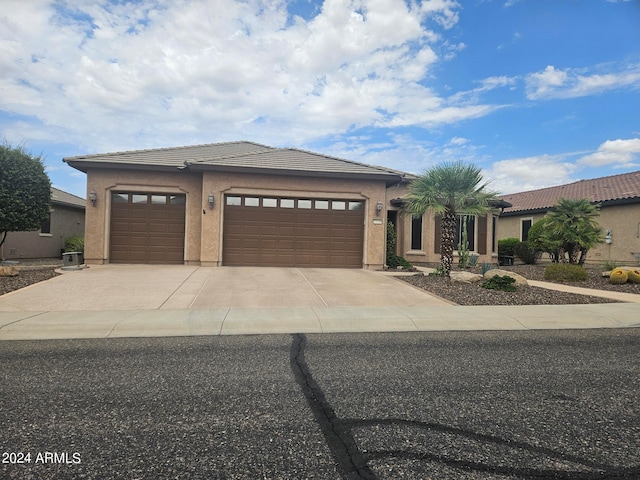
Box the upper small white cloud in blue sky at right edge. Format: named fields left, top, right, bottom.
left=525, top=65, right=640, bottom=100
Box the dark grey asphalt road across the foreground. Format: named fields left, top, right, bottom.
left=0, top=329, right=640, bottom=480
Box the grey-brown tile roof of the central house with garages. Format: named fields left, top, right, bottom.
left=64, top=142, right=409, bottom=180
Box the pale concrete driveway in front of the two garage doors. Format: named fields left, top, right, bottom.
left=0, top=265, right=448, bottom=312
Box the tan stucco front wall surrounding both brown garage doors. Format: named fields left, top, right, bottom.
left=85, top=169, right=386, bottom=269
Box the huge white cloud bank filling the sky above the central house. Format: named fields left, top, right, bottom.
left=0, top=0, right=496, bottom=151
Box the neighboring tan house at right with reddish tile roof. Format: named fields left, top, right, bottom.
left=498, top=171, right=640, bottom=264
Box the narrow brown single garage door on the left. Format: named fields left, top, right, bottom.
left=109, top=192, right=186, bottom=264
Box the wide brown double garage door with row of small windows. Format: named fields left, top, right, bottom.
left=222, top=195, right=364, bottom=268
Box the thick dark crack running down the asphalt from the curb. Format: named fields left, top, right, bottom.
left=290, top=333, right=376, bottom=480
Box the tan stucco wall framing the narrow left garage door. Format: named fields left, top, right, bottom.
left=84, top=169, right=204, bottom=264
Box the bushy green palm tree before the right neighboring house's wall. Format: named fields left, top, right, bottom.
left=528, top=198, right=603, bottom=265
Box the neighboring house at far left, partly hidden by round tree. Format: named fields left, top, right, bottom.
left=0, top=188, right=86, bottom=260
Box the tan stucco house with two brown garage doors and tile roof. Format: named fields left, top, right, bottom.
left=64, top=142, right=504, bottom=269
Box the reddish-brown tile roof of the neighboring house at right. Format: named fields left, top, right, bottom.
left=500, top=171, right=640, bottom=213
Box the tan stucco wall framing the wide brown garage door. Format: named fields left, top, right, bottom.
left=201, top=172, right=386, bottom=269
